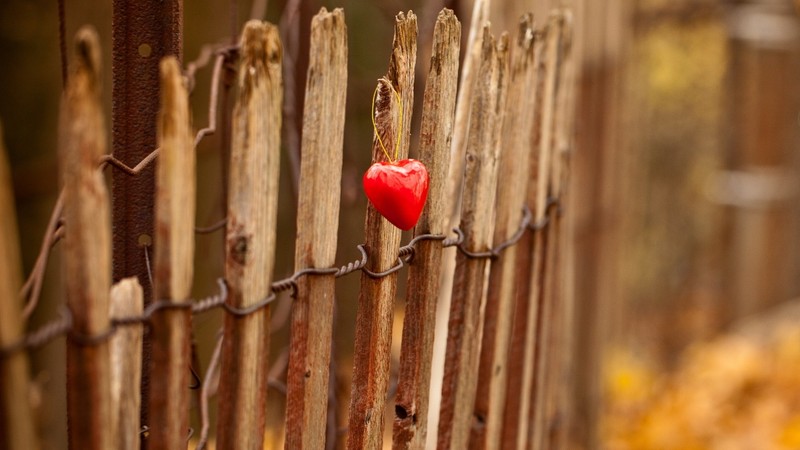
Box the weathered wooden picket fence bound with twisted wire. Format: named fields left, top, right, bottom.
left=0, top=2, right=574, bottom=449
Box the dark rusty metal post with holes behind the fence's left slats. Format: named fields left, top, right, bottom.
left=111, top=0, right=183, bottom=436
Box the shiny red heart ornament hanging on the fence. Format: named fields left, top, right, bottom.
left=363, top=159, right=428, bottom=230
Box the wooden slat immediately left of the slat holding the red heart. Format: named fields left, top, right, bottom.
left=285, top=8, right=347, bottom=449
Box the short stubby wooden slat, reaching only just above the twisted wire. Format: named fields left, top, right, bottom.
left=110, top=277, right=144, bottom=450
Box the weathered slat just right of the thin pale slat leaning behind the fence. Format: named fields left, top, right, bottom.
left=438, top=26, right=508, bottom=449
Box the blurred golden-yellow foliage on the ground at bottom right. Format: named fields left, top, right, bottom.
left=601, top=327, right=800, bottom=450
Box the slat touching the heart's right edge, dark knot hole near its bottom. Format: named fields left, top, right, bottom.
left=393, top=9, right=461, bottom=449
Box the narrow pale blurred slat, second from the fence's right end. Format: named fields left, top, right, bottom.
left=520, top=13, right=563, bottom=449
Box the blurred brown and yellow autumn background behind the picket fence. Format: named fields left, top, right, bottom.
left=0, top=0, right=800, bottom=449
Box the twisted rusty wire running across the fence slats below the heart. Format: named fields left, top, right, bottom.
left=0, top=199, right=560, bottom=360
